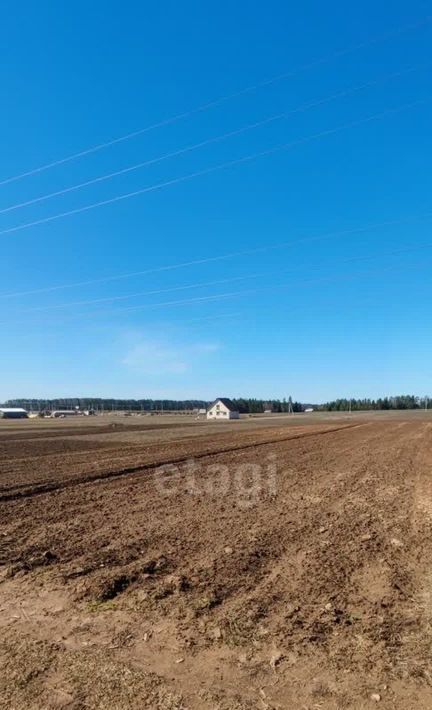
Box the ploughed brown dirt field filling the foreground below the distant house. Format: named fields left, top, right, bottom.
left=0, top=417, right=432, bottom=710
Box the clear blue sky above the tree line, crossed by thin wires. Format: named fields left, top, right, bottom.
left=0, top=0, right=432, bottom=401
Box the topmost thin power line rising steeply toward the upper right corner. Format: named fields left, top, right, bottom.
left=0, top=15, right=432, bottom=186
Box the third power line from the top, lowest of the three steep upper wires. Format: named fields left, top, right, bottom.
left=0, top=97, right=430, bottom=235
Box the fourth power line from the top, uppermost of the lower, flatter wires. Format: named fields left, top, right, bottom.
left=0, top=212, right=432, bottom=298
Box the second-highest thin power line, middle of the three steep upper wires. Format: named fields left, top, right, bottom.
left=0, top=62, right=431, bottom=214
